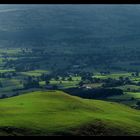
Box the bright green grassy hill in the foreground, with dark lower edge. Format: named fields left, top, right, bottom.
left=0, top=91, right=140, bottom=135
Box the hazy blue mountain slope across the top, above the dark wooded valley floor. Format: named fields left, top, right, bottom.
left=0, top=5, right=140, bottom=46
